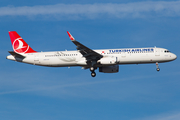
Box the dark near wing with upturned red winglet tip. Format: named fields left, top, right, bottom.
left=67, top=31, right=103, bottom=63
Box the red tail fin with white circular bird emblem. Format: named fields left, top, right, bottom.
left=9, top=31, right=36, bottom=53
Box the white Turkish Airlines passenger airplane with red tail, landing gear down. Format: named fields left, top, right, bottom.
left=6, top=31, right=177, bottom=77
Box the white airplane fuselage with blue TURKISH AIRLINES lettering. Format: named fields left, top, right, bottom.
left=7, top=47, right=176, bottom=67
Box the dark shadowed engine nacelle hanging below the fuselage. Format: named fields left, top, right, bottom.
left=99, top=65, right=119, bottom=73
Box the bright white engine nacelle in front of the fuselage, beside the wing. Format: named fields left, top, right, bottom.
left=98, top=56, right=118, bottom=65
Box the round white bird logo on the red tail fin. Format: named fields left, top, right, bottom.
left=13, top=38, right=29, bottom=53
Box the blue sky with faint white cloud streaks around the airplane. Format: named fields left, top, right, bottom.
left=0, top=0, right=180, bottom=120
